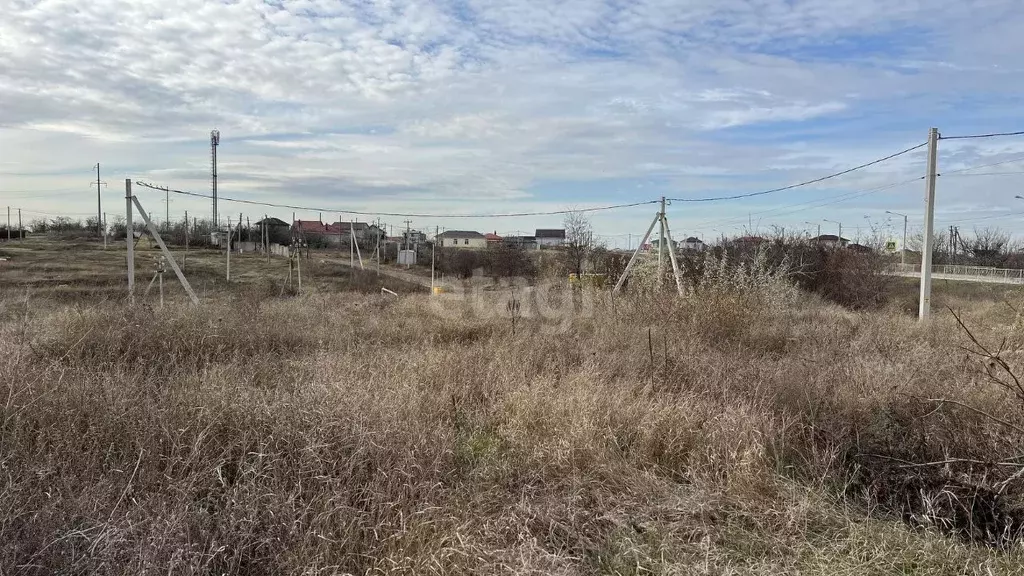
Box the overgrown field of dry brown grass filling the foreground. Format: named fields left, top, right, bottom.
left=0, top=236, right=1024, bottom=576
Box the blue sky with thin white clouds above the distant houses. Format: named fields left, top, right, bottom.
left=0, top=0, right=1024, bottom=247
